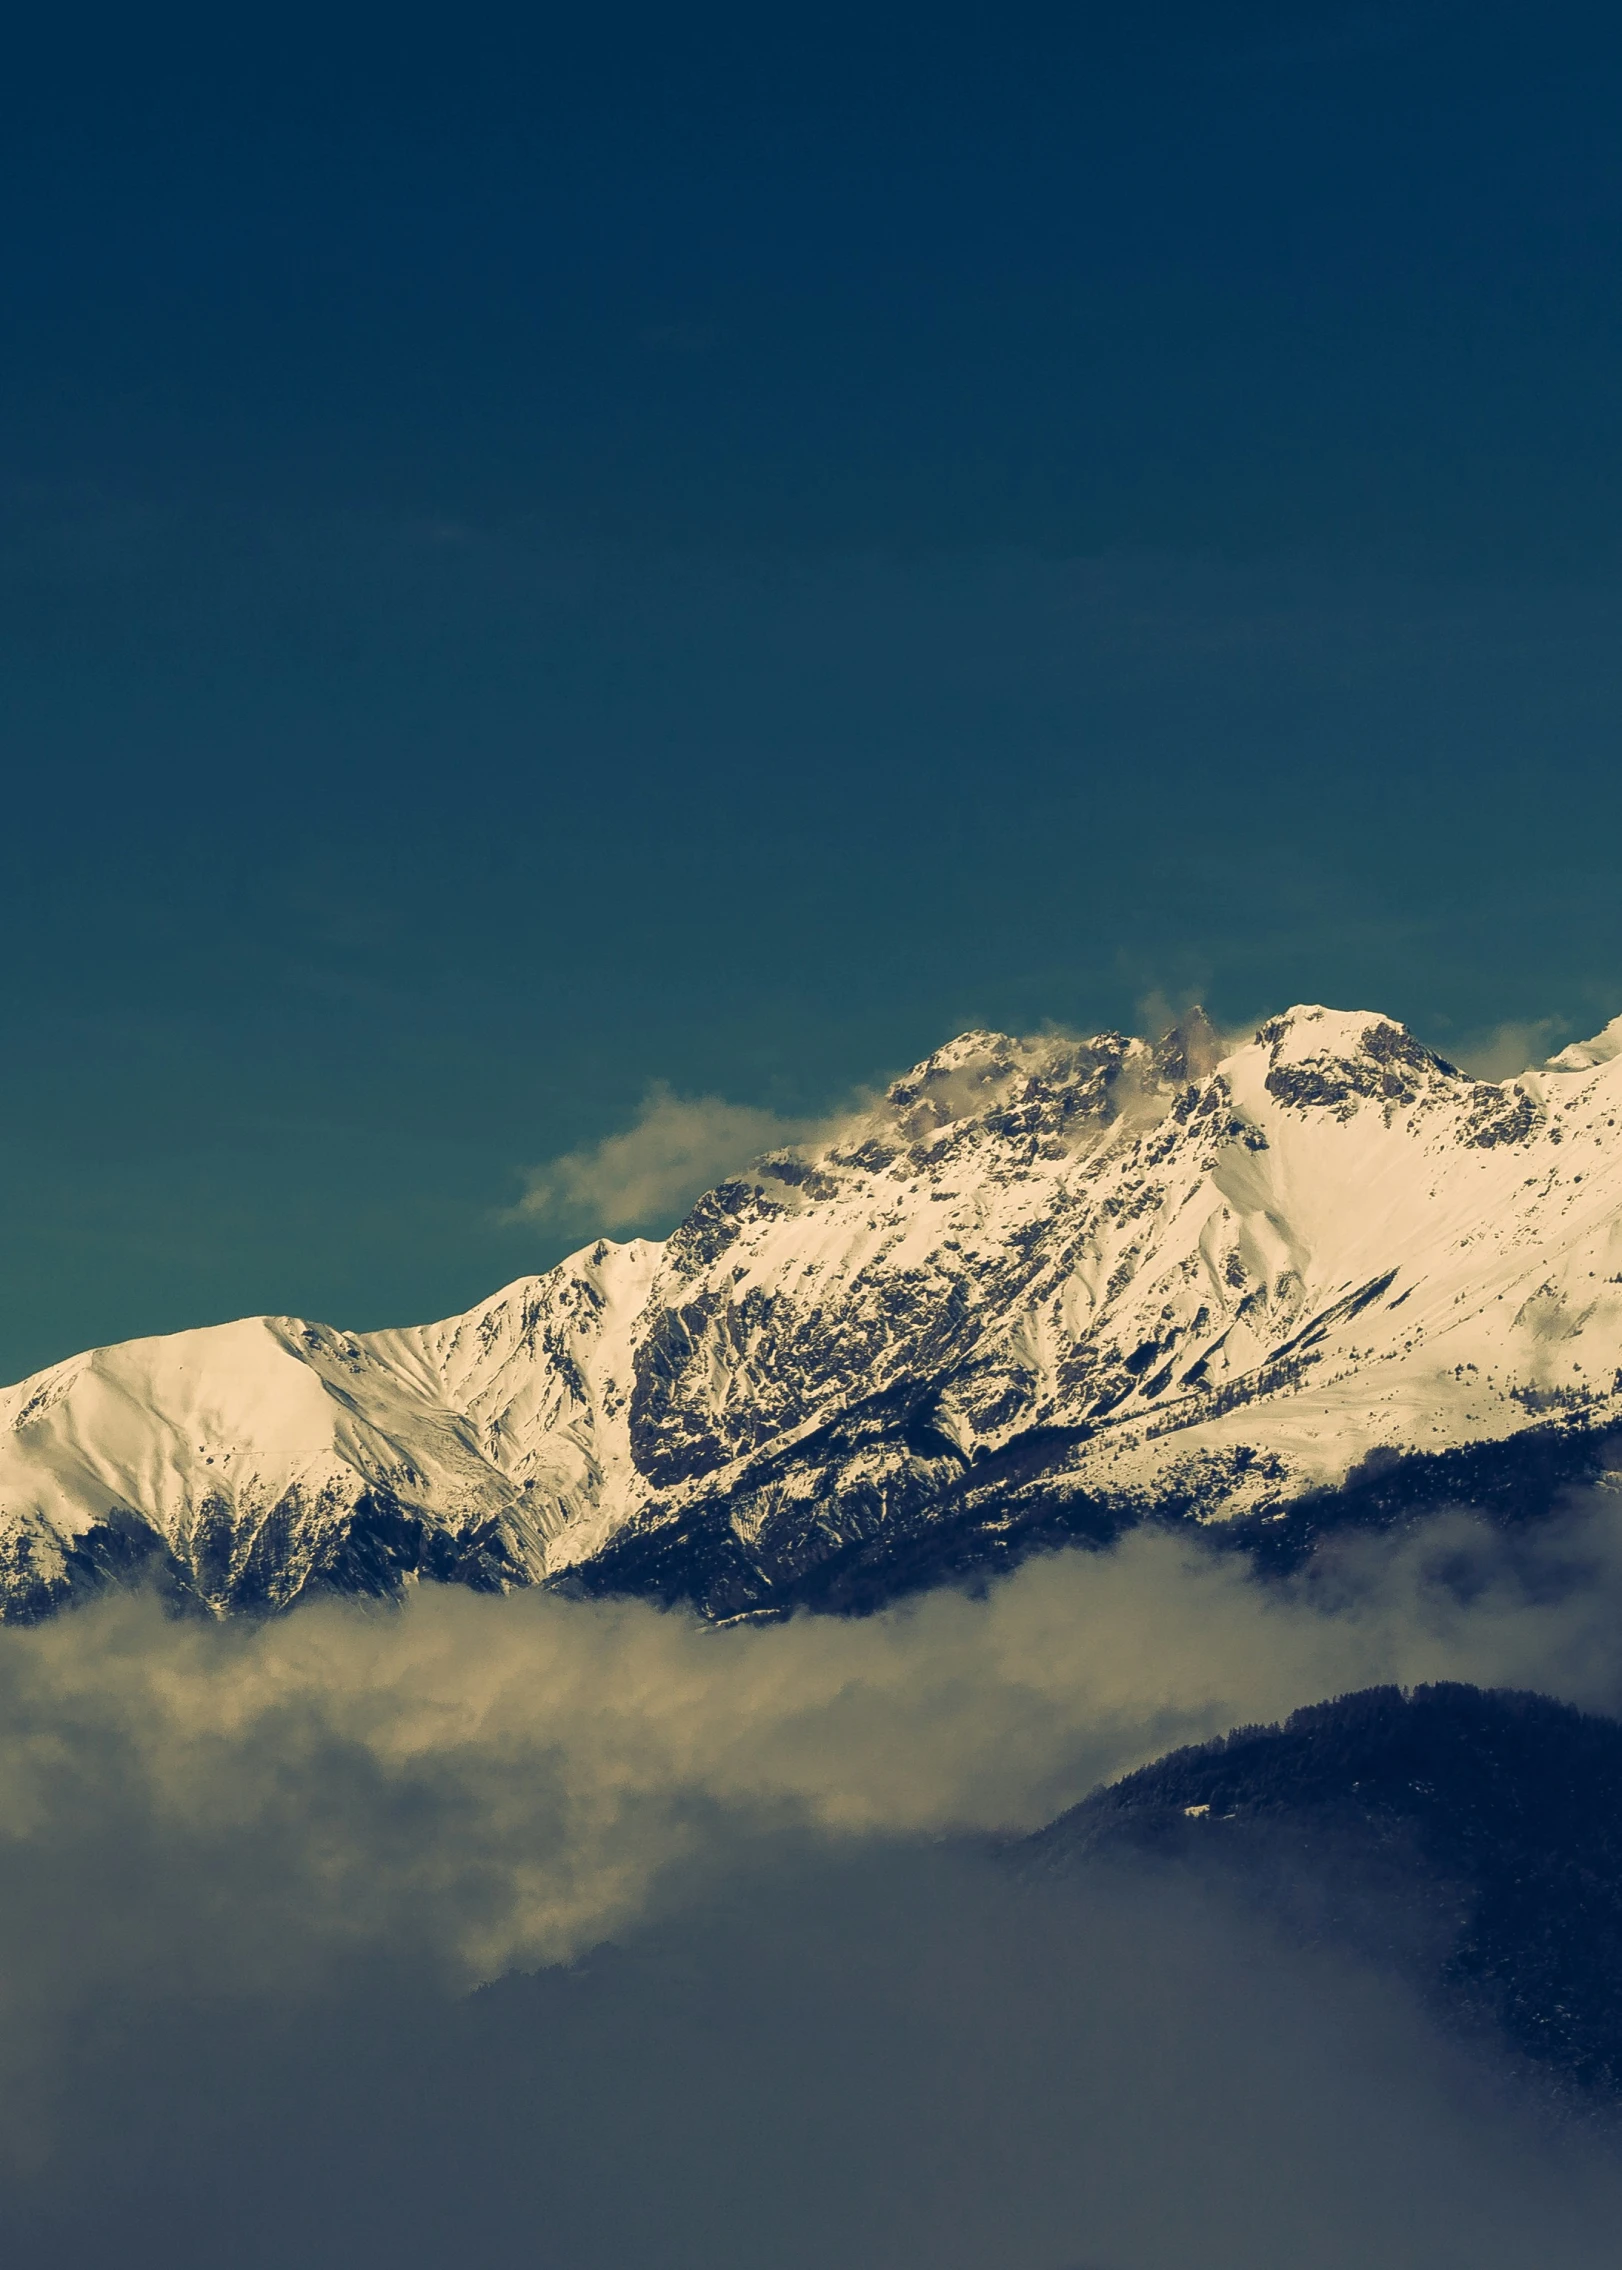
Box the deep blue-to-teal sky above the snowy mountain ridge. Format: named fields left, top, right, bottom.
left=0, top=0, right=1622, bottom=1376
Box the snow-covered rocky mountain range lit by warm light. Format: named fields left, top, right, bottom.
left=0, top=1008, right=1622, bottom=1619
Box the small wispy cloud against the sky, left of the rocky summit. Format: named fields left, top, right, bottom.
left=513, top=1083, right=814, bottom=1230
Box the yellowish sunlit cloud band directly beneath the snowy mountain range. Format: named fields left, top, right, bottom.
left=0, top=1494, right=1622, bottom=1998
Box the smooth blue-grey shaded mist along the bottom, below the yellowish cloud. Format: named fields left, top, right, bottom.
left=15, top=1846, right=1622, bottom=2270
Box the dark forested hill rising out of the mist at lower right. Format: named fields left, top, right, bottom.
left=1016, top=1687, right=1622, bottom=2095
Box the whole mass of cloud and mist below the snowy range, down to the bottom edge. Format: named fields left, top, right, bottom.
left=0, top=1494, right=1622, bottom=2270
